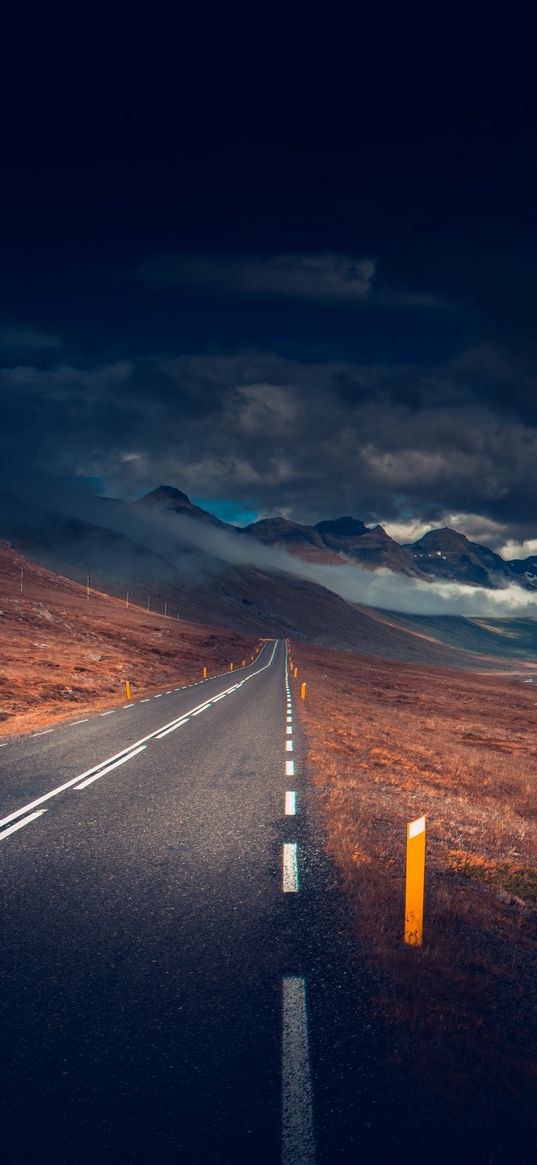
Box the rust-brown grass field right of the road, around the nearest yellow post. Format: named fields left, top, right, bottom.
left=292, top=644, right=537, bottom=1137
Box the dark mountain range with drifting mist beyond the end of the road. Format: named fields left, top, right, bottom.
left=0, top=486, right=537, bottom=668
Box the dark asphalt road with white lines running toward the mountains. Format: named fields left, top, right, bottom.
left=0, top=641, right=400, bottom=1165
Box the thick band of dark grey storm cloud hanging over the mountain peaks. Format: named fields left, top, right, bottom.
left=0, top=335, right=537, bottom=541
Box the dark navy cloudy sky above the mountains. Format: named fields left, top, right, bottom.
left=0, top=33, right=537, bottom=555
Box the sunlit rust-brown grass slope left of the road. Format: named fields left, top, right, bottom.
left=0, top=543, right=257, bottom=736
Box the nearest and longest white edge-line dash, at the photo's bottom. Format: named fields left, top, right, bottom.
left=282, top=975, right=316, bottom=1165
